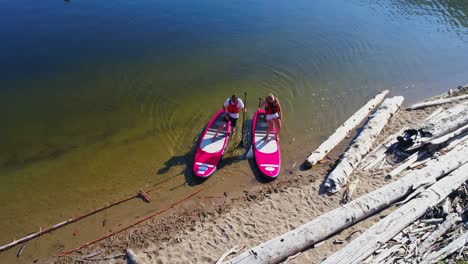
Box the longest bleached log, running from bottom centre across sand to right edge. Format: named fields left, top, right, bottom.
left=226, top=142, right=468, bottom=264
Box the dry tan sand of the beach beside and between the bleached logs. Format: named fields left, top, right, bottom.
left=49, top=89, right=466, bottom=263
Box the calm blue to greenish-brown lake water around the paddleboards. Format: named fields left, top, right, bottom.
left=0, top=0, right=468, bottom=258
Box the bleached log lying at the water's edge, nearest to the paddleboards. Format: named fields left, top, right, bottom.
left=304, top=90, right=388, bottom=167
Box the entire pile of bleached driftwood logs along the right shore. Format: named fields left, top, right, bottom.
left=221, top=86, right=468, bottom=264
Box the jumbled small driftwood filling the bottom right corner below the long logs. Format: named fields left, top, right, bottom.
left=364, top=183, right=468, bottom=263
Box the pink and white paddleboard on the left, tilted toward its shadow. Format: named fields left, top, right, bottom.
left=193, top=109, right=231, bottom=178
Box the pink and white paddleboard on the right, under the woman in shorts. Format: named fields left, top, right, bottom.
left=252, top=110, right=281, bottom=178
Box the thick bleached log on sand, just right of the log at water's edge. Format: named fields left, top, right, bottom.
left=324, top=96, right=404, bottom=193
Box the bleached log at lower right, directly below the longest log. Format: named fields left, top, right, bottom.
left=322, top=163, right=468, bottom=264
